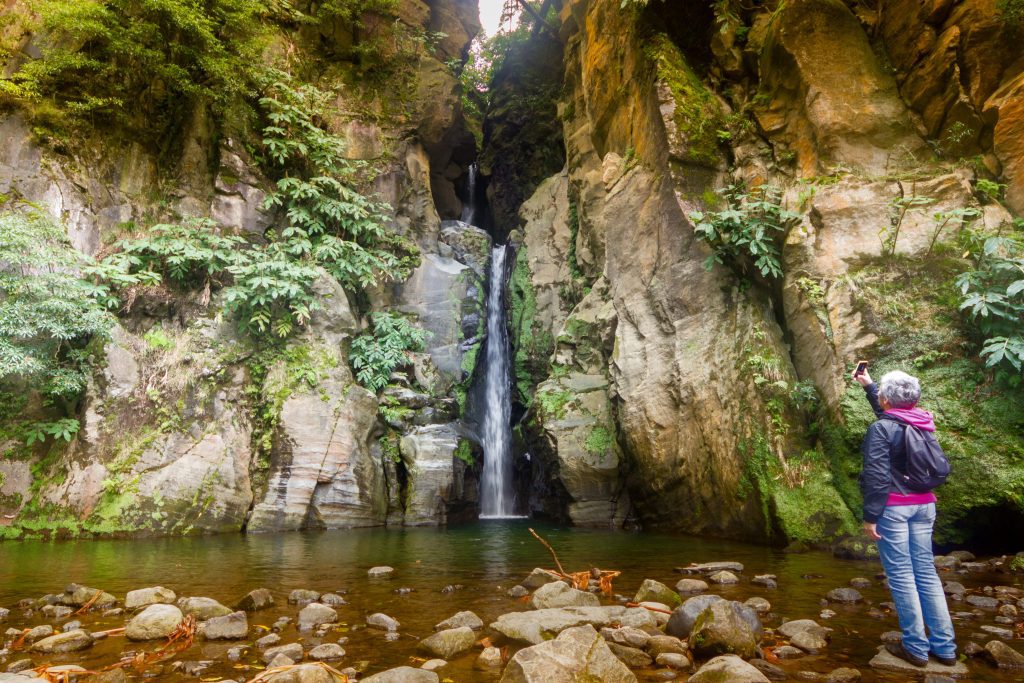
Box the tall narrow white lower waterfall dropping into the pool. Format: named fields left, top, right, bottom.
left=480, top=245, right=515, bottom=518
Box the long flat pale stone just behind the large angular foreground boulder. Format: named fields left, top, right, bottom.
left=490, top=606, right=654, bottom=645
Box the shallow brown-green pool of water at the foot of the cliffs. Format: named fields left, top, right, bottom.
left=0, top=520, right=1024, bottom=681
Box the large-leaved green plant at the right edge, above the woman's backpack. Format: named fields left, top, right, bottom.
left=956, top=230, right=1024, bottom=378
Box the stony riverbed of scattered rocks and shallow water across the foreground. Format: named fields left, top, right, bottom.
left=0, top=552, right=1024, bottom=683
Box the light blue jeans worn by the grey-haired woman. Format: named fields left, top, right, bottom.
left=877, top=503, right=956, bottom=658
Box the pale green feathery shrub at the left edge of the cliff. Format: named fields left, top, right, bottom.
left=0, top=211, right=128, bottom=401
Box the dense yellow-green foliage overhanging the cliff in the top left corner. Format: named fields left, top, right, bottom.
left=0, top=0, right=268, bottom=144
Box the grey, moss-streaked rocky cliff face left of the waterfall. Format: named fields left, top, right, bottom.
left=0, top=0, right=489, bottom=537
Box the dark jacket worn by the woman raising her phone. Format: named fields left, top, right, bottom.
left=860, top=382, right=907, bottom=523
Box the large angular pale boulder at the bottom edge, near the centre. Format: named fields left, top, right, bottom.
left=501, top=625, right=637, bottom=683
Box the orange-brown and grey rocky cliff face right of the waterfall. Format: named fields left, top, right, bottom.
left=493, top=0, right=1022, bottom=543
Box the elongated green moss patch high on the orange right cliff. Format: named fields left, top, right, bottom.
left=644, top=34, right=726, bottom=166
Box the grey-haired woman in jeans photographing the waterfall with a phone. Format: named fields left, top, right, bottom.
left=853, top=371, right=956, bottom=667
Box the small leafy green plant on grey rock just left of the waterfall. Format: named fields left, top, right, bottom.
left=348, top=312, right=427, bottom=391
